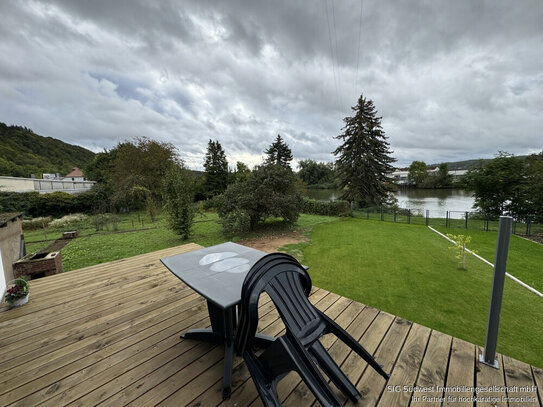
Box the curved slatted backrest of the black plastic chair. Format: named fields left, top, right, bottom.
left=236, top=253, right=324, bottom=354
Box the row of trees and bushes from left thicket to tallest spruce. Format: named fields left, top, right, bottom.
left=31, top=96, right=395, bottom=238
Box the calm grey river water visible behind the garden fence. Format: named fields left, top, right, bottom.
left=307, top=188, right=474, bottom=216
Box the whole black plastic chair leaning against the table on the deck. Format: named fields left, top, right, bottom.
left=235, top=253, right=389, bottom=406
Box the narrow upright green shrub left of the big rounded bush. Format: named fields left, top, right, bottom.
left=162, top=165, right=195, bottom=239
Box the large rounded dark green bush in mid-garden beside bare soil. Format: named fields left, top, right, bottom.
left=216, top=165, right=302, bottom=234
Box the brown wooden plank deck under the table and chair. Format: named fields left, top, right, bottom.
left=0, top=245, right=543, bottom=407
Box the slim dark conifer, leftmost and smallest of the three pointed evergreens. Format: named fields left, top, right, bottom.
left=204, top=140, right=228, bottom=198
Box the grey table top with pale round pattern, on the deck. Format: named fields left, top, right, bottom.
left=160, top=242, right=267, bottom=309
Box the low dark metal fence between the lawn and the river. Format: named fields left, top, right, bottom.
left=355, top=207, right=543, bottom=236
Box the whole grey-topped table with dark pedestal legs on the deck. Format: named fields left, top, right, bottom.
left=160, top=242, right=275, bottom=398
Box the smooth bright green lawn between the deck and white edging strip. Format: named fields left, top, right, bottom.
left=301, top=219, right=543, bottom=366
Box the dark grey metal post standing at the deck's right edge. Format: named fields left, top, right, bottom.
left=479, top=216, right=513, bottom=368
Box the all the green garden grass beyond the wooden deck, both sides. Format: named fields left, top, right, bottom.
left=25, top=212, right=543, bottom=367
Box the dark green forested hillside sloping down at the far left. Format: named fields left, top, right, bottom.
left=0, top=122, right=94, bottom=178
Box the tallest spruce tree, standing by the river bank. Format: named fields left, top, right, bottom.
left=333, top=95, right=396, bottom=206
